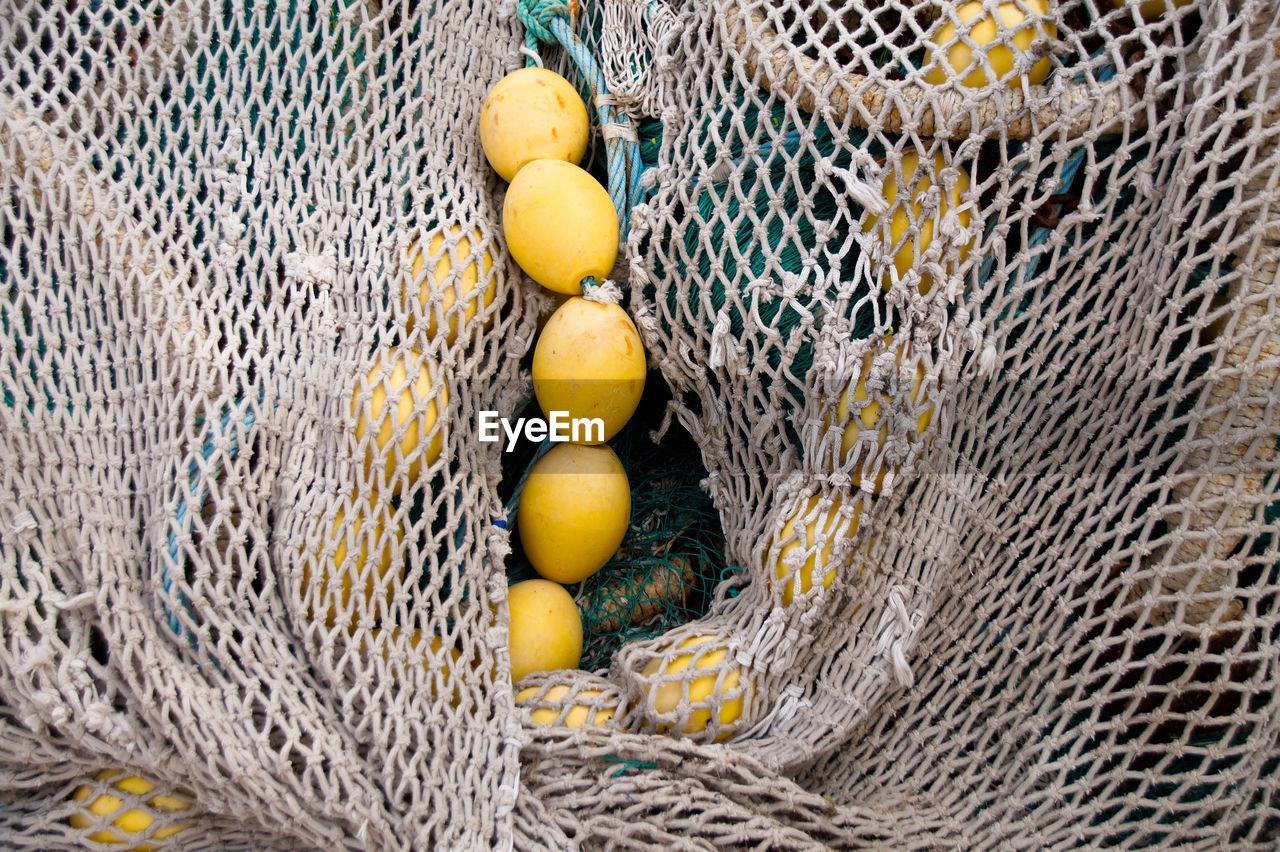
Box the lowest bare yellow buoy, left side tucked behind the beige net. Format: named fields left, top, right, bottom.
left=507, top=580, right=582, bottom=683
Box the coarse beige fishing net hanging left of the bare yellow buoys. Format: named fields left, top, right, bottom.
left=0, top=0, right=540, bottom=849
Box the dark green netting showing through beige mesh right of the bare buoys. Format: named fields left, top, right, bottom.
left=645, top=87, right=883, bottom=452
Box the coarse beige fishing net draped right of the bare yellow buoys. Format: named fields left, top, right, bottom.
left=532, top=0, right=1280, bottom=848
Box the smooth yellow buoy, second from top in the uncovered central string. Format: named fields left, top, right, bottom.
left=502, top=160, right=618, bottom=296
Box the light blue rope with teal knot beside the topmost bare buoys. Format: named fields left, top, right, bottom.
left=516, top=0, right=644, bottom=250
